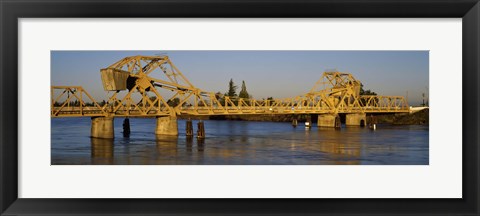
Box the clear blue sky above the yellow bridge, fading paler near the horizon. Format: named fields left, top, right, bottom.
left=51, top=50, right=429, bottom=106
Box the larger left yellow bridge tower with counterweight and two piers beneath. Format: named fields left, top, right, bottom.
left=92, top=56, right=200, bottom=138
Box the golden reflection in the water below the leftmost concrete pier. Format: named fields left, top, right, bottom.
left=90, top=138, right=114, bottom=164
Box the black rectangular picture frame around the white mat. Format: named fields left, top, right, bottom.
left=0, top=0, right=480, bottom=215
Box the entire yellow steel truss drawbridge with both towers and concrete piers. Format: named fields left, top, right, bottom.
left=51, top=56, right=412, bottom=138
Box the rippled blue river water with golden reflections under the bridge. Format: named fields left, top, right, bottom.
left=51, top=118, right=429, bottom=165
